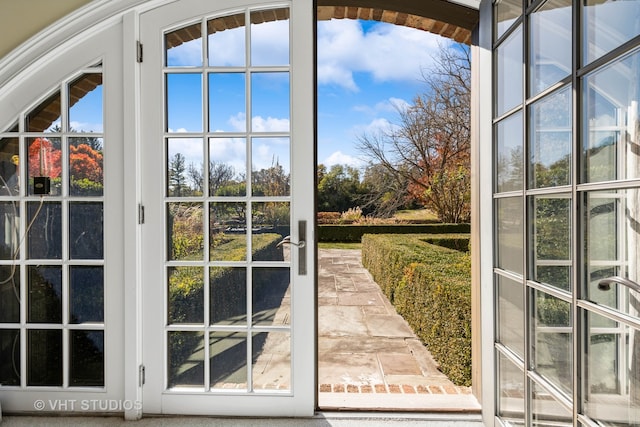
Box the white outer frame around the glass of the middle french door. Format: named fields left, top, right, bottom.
left=137, top=0, right=317, bottom=417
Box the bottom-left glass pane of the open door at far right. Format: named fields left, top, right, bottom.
left=497, top=353, right=524, bottom=426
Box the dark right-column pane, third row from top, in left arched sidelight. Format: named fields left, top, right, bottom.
left=69, top=202, right=104, bottom=259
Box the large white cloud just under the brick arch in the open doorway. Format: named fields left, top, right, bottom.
left=318, top=19, right=448, bottom=91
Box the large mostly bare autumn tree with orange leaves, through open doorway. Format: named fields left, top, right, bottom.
left=358, top=46, right=471, bottom=223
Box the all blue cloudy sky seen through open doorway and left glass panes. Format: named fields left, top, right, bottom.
left=72, top=19, right=451, bottom=173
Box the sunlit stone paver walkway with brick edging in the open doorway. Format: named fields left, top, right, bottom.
left=318, top=249, right=480, bottom=412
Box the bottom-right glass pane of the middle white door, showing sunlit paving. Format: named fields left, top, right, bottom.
left=252, top=332, right=291, bottom=392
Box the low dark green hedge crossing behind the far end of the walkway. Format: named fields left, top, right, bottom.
left=318, top=224, right=470, bottom=242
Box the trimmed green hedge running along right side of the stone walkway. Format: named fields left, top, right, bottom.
left=362, top=234, right=471, bottom=386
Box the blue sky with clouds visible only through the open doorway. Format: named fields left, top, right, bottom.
left=318, top=19, right=450, bottom=166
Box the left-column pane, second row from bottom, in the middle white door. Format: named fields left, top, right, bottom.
left=167, top=267, right=204, bottom=324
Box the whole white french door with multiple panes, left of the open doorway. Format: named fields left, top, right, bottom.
left=140, top=0, right=316, bottom=416
